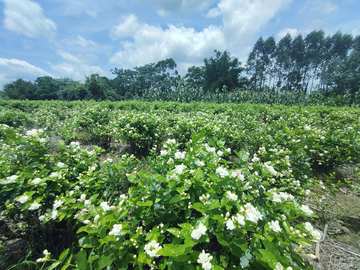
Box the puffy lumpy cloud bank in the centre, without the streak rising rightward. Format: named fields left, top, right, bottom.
left=110, top=15, right=225, bottom=68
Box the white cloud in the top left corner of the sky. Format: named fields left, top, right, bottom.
left=3, top=0, right=57, bottom=38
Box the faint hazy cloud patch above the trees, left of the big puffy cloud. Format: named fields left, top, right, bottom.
left=48, top=50, right=105, bottom=80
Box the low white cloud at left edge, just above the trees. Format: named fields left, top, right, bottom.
left=0, top=58, right=50, bottom=76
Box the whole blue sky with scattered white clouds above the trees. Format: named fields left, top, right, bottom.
left=0, top=0, right=360, bottom=89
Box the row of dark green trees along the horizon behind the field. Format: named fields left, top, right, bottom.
left=0, top=30, right=360, bottom=101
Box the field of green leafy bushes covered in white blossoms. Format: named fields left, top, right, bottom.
left=0, top=101, right=360, bottom=270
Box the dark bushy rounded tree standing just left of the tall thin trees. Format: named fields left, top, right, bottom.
left=204, top=50, right=243, bottom=91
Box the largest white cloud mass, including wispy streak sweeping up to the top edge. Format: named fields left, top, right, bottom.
left=110, top=0, right=291, bottom=68
